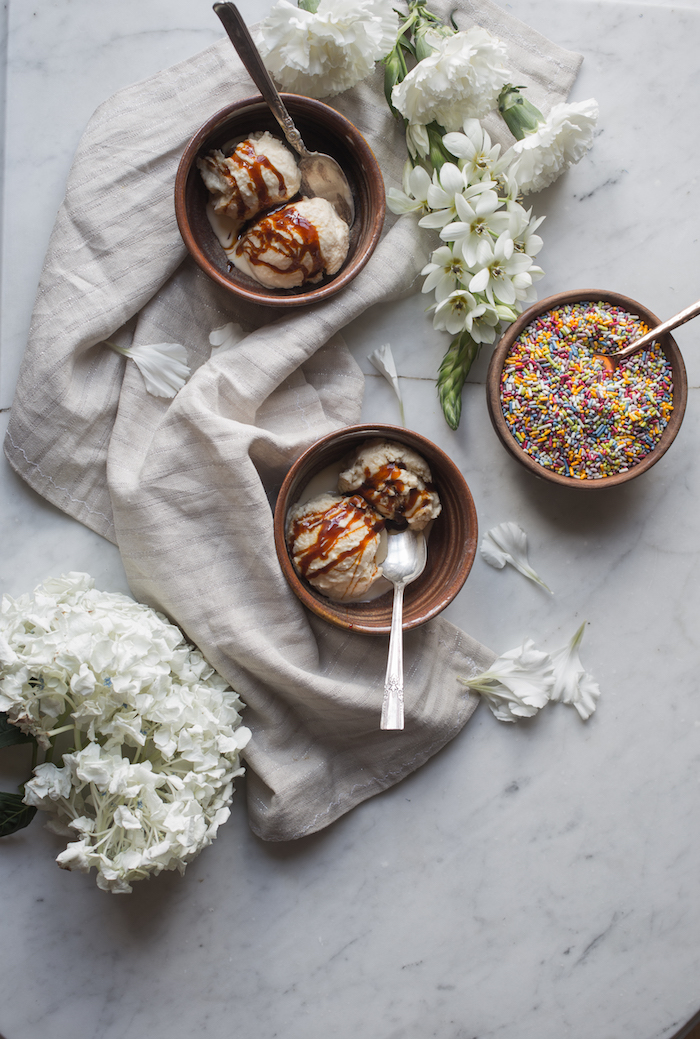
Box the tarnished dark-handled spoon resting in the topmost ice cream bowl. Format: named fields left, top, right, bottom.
left=214, top=3, right=355, bottom=227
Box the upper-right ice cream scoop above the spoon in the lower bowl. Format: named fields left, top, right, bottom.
left=338, top=439, right=441, bottom=530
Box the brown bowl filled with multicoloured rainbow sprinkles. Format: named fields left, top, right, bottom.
left=487, top=289, right=688, bottom=488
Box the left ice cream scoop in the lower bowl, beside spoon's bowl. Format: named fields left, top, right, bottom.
left=287, top=494, right=384, bottom=600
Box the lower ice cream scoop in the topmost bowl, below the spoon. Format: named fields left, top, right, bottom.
left=232, top=197, right=350, bottom=289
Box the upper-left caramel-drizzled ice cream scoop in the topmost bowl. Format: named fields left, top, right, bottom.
left=197, top=130, right=301, bottom=230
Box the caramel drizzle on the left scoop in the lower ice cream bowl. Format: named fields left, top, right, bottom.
left=291, top=495, right=384, bottom=578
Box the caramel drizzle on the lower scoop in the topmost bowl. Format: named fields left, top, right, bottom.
left=232, top=205, right=324, bottom=279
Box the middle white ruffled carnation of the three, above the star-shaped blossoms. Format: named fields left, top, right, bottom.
left=392, top=26, right=509, bottom=131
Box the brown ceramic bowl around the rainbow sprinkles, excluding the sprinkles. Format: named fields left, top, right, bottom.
left=486, top=289, right=688, bottom=490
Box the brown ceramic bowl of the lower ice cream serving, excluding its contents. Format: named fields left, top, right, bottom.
left=274, top=425, right=478, bottom=635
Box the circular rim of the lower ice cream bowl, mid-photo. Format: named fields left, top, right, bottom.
left=273, top=422, right=479, bottom=635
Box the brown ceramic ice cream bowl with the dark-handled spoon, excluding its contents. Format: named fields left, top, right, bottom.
left=174, top=94, right=385, bottom=307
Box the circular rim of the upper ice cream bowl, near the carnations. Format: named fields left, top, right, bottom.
left=174, top=94, right=386, bottom=307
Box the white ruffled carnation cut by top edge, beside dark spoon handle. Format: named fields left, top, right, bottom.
left=257, top=0, right=399, bottom=98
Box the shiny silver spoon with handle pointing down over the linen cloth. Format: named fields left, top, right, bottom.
left=380, top=530, right=428, bottom=728
